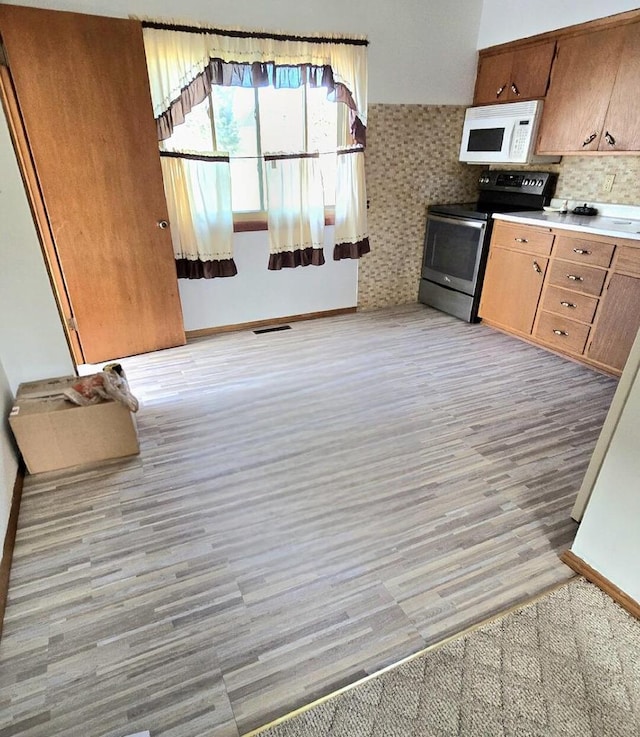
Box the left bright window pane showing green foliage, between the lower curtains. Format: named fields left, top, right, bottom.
left=211, top=86, right=263, bottom=212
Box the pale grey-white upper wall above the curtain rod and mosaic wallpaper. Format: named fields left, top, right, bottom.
left=0, top=0, right=482, bottom=105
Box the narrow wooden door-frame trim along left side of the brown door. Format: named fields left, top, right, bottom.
left=0, top=67, right=86, bottom=366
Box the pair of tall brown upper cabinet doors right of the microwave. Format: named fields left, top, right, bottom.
left=537, top=23, right=640, bottom=153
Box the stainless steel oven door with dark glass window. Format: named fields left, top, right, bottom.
left=422, top=214, right=487, bottom=296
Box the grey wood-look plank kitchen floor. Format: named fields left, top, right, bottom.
left=0, top=305, right=616, bottom=737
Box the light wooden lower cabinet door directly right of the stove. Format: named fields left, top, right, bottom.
left=479, top=246, right=548, bottom=335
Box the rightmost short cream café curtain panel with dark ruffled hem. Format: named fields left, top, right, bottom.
left=333, top=147, right=371, bottom=261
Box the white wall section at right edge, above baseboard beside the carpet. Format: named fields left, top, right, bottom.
left=571, top=358, right=640, bottom=602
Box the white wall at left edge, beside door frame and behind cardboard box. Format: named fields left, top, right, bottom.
left=0, top=99, right=73, bottom=542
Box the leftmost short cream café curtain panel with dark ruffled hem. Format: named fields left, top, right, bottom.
left=161, top=152, right=237, bottom=278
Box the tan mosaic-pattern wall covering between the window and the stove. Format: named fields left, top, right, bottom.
left=358, top=104, right=481, bottom=309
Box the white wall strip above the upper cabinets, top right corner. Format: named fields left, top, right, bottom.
left=478, top=0, right=638, bottom=49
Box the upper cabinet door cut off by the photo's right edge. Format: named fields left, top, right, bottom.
left=599, top=23, right=640, bottom=151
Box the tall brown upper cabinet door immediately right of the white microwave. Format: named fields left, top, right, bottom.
left=537, top=27, right=625, bottom=154
